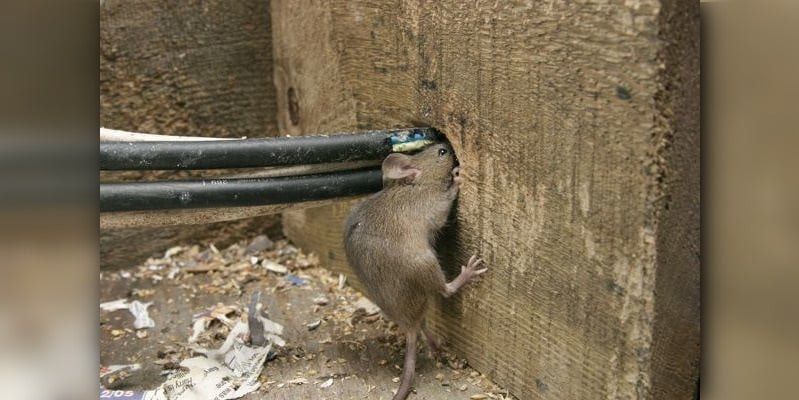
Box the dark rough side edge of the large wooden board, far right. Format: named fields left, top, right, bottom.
left=651, top=1, right=701, bottom=400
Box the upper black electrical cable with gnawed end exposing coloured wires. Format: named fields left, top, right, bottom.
left=100, top=128, right=439, bottom=170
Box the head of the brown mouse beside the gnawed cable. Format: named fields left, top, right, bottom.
left=382, top=143, right=455, bottom=187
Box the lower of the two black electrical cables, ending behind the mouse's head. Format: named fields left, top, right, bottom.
left=100, top=169, right=383, bottom=212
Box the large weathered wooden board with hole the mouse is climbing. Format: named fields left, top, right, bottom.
left=271, top=0, right=699, bottom=399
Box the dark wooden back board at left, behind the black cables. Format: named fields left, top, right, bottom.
left=100, top=0, right=279, bottom=268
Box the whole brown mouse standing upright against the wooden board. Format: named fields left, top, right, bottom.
left=344, top=143, right=486, bottom=400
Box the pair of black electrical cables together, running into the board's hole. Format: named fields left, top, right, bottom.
left=100, top=128, right=442, bottom=213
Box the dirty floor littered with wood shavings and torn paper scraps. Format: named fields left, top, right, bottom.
left=100, top=235, right=510, bottom=399
